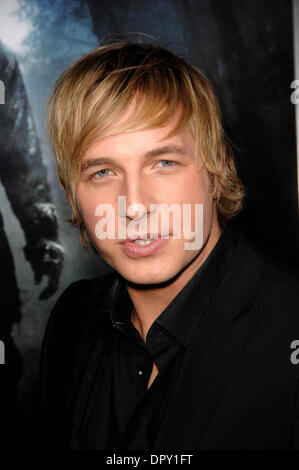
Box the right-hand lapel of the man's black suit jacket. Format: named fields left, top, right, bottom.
left=153, top=236, right=264, bottom=450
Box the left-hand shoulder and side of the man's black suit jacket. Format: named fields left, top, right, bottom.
left=39, top=273, right=116, bottom=448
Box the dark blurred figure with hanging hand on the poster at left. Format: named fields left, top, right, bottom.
left=0, top=42, right=64, bottom=448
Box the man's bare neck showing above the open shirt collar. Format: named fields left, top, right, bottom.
left=127, top=213, right=221, bottom=342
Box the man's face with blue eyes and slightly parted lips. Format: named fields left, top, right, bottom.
left=76, top=112, right=218, bottom=284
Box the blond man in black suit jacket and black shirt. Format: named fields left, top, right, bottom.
left=41, top=42, right=299, bottom=450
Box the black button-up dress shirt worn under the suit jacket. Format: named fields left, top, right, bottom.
left=79, top=227, right=238, bottom=450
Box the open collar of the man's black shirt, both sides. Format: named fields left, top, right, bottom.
left=101, top=223, right=240, bottom=347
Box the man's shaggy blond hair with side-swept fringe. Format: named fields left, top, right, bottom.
left=48, top=41, right=244, bottom=246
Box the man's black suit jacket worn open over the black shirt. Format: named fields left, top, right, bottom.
left=40, top=229, right=299, bottom=450
